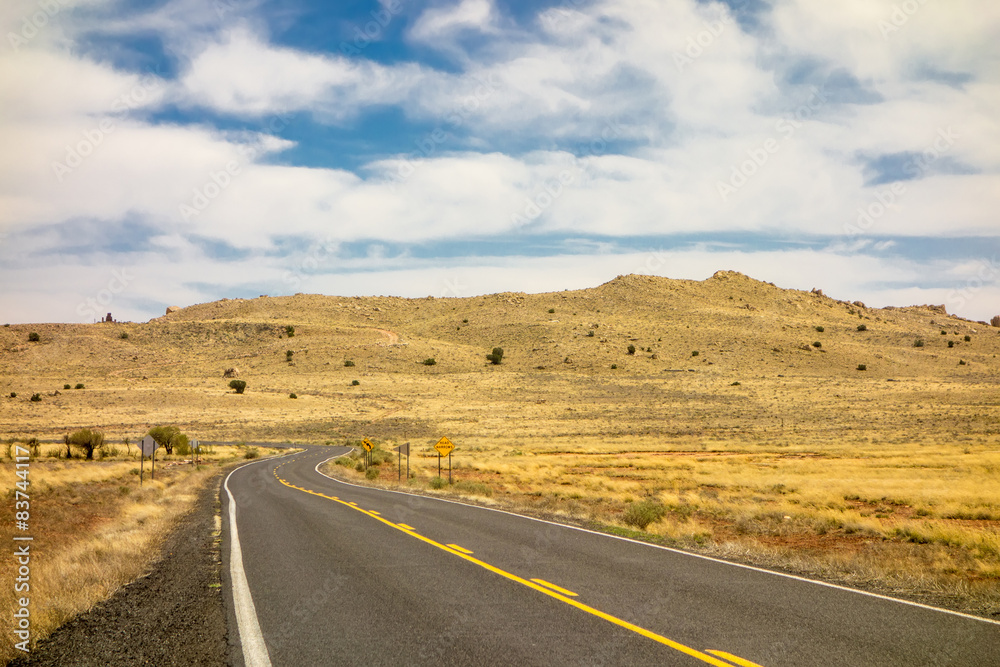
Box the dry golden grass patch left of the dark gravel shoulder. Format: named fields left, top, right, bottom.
left=0, top=447, right=286, bottom=663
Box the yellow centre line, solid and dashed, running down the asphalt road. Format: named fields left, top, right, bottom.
left=274, top=461, right=761, bottom=667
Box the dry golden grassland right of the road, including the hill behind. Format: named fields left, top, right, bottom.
left=0, top=272, right=1000, bottom=636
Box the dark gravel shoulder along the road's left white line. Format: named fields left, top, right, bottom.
left=9, top=469, right=228, bottom=667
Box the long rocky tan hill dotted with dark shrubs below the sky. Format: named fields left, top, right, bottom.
left=0, top=271, right=1000, bottom=448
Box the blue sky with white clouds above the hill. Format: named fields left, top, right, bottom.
left=0, top=0, right=1000, bottom=323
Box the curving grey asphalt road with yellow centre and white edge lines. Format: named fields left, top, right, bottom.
left=222, top=447, right=1000, bottom=667
